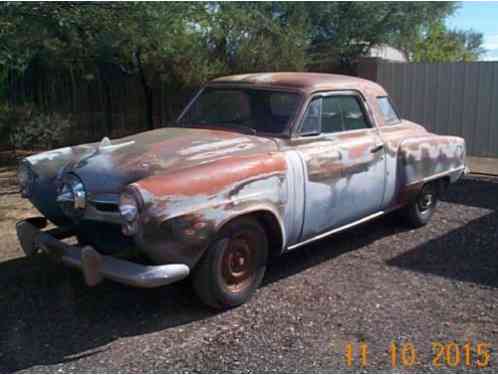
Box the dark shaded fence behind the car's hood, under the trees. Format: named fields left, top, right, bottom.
left=9, top=67, right=197, bottom=144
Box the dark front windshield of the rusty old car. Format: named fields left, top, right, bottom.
left=179, top=87, right=300, bottom=134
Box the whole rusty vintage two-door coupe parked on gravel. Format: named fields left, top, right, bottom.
left=17, top=73, right=466, bottom=308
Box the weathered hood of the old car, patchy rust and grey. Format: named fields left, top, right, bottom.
left=28, top=127, right=277, bottom=194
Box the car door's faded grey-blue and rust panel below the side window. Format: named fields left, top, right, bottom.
left=282, top=129, right=385, bottom=240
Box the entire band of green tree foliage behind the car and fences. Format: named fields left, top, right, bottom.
left=0, top=1, right=482, bottom=147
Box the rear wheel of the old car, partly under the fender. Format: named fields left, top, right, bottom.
left=402, top=182, right=439, bottom=228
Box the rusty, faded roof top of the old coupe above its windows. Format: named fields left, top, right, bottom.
left=210, top=72, right=387, bottom=96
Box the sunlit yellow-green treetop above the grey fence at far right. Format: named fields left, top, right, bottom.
left=412, top=21, right=483, bottom=63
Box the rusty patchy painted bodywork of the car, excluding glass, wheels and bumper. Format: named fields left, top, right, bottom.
left=16, top=73, right=465, bottom=280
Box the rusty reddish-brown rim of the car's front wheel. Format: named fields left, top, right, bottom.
left=221, top=233, right=256, bottom=293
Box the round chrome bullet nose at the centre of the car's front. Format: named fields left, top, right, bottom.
left=57, top=174, right=86, bottom=218
